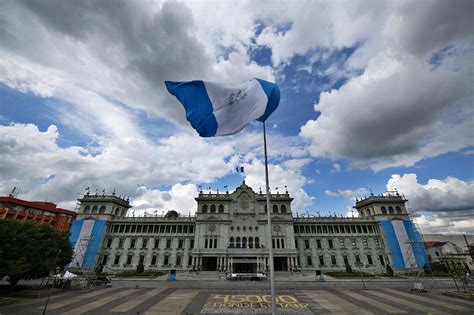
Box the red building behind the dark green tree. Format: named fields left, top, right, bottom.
left=0, top=197, right=77, bottom=231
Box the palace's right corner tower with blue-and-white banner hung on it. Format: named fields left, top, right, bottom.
left=354, top=191, right=428, bottom=270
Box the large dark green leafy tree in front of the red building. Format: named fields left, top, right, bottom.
left=0, top=220, right=72, bottom=285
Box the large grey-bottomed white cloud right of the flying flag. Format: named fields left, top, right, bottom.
left=300, top=52, right=474, bottom=170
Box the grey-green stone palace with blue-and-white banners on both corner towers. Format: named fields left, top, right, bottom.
left=70, top=182, right=428, bottom=273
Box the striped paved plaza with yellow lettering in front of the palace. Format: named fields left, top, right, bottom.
left=0, top=281, right=474, bottom=315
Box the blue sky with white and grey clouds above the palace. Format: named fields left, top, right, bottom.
left=0, top=0, right=474, bottom=233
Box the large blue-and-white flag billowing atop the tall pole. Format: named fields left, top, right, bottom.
left=165, top=79, right=280, bottom=137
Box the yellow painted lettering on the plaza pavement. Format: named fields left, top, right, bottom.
left=204, top=294, right=308, bottom=308
